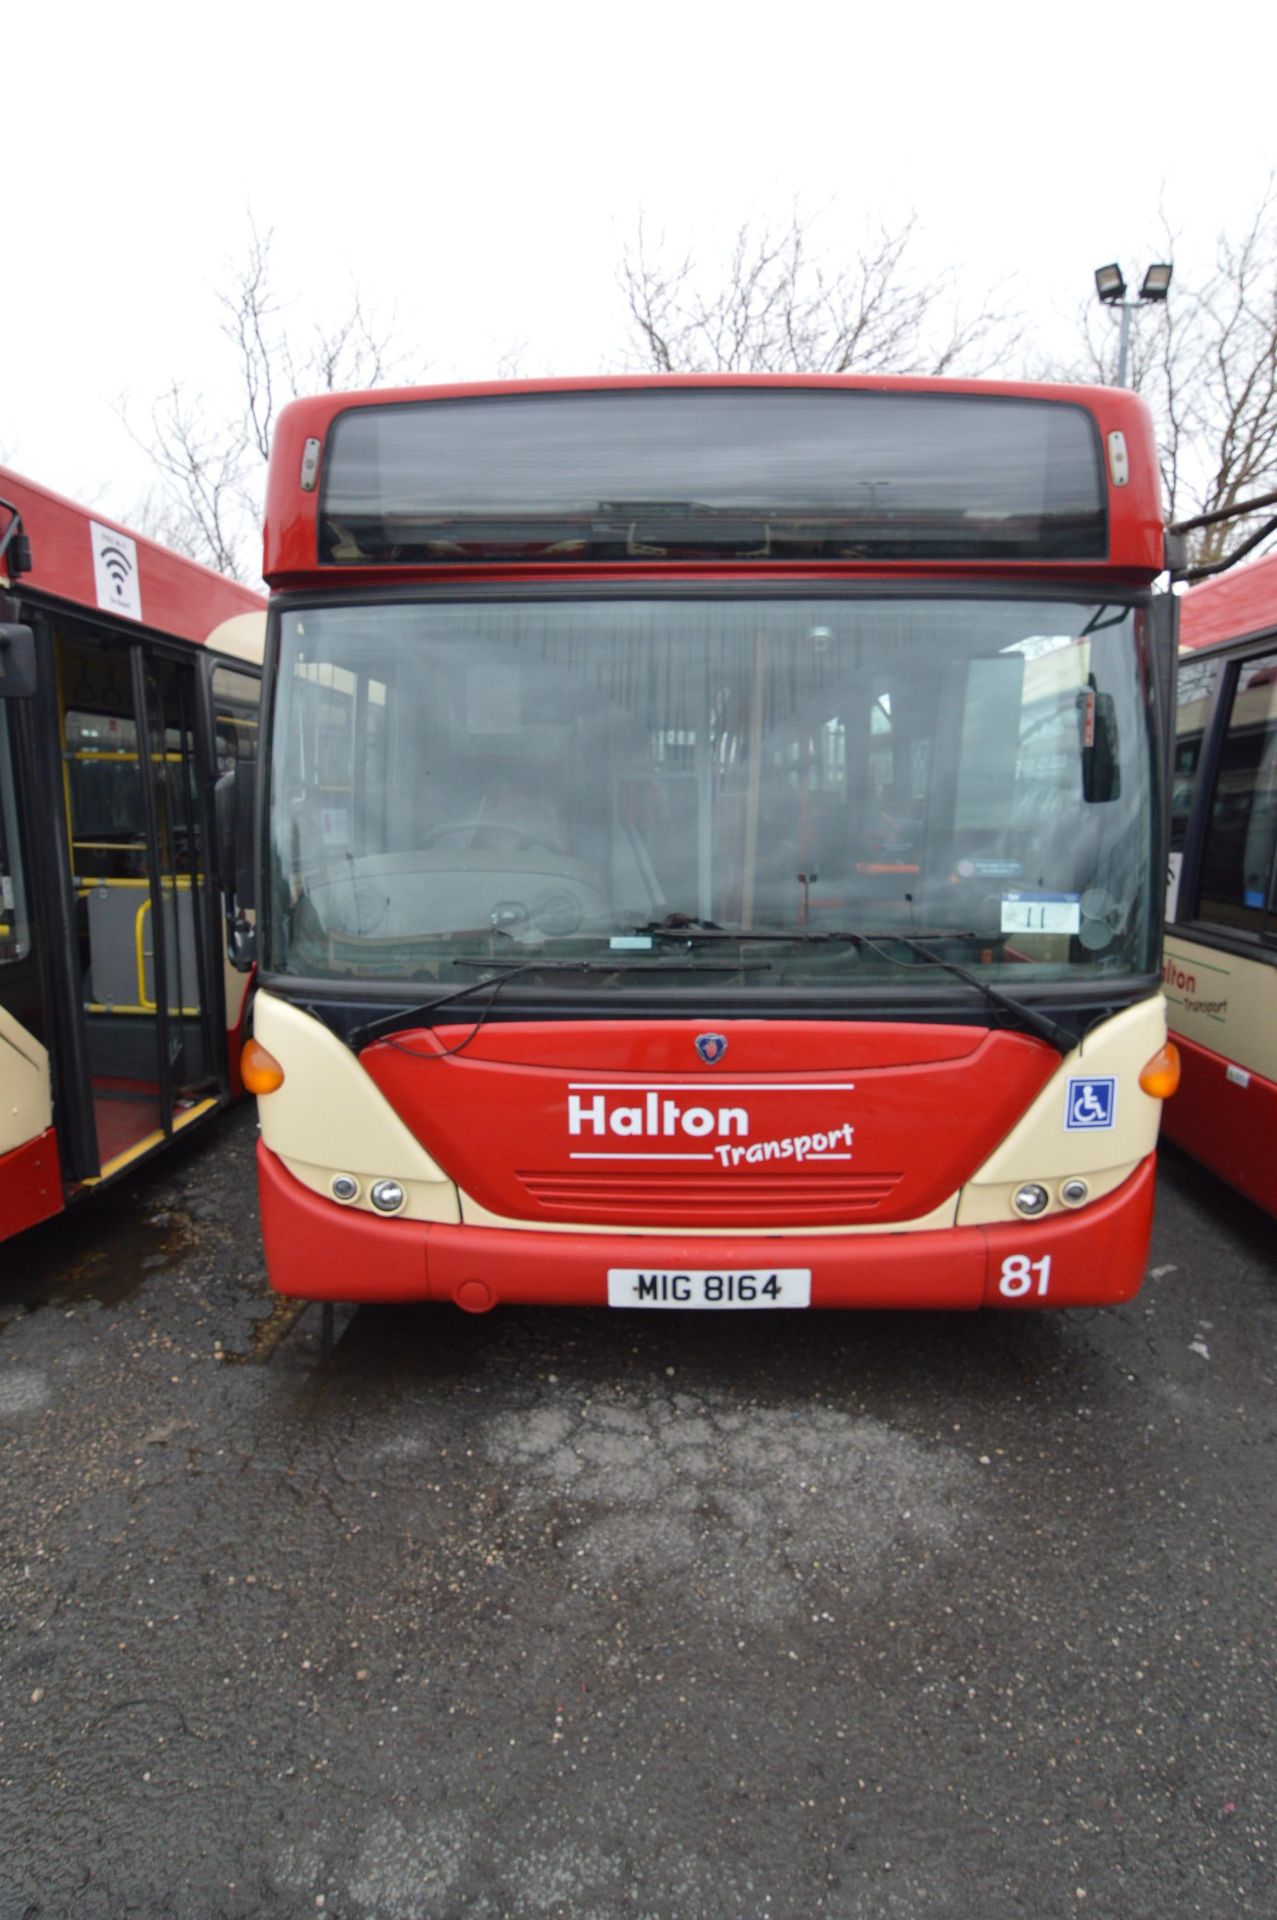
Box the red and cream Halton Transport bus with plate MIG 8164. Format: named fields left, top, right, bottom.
left=242, top=376, right=1173, bottom=1311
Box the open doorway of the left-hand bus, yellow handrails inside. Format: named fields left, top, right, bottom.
left=0, top=605, right=227, bottom=1231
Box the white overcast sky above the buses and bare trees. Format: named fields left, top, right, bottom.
left=9, top=0, right=1277, bottom=572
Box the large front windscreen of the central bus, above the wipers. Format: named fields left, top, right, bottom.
left=263, top=588, right=1158, bottom=1000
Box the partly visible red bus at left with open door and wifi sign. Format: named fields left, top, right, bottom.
left=0, top=470, right=265, bottom=1238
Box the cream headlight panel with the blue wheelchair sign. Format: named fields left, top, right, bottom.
left=958, top=995, right=1166, bottom=1227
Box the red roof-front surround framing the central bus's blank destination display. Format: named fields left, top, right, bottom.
left=261, top=374, right=1166, bottom=591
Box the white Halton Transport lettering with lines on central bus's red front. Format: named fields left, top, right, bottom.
left=568, top=1081, right=855, bottom=1167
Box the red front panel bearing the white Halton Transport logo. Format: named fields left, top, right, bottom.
left=359, top=1020, right=1058, bottom=1229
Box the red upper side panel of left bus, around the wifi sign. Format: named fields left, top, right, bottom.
left=0, top=467, right=265, bottom=645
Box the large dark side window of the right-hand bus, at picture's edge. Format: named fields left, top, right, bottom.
left=1200, top=653, right=1277, bottom=933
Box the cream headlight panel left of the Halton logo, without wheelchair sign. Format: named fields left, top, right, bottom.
left=253, top=993, right=461, bottom=1221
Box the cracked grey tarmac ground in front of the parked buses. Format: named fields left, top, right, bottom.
left=0, top=1110, right=1277, bottom=1920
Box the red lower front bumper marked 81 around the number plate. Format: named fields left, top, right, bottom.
left=257, top=1142, right=1154, bottom=1311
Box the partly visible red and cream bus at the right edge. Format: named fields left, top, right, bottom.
left=1164, top=555, right=1277, bottom=1213
